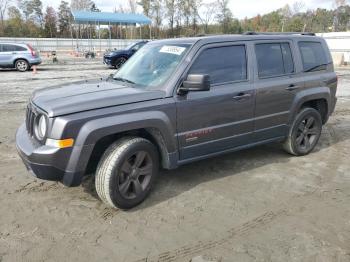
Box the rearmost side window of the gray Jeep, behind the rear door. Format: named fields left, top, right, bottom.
left=299, top=42, right=327, bottom=72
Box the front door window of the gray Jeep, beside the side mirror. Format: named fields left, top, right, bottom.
left=188, top=45, right=247, bottom=85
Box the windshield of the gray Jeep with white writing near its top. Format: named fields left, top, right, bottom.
left=113, top=44, right=190, bottom=88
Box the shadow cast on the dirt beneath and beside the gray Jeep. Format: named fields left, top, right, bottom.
left=83, top=123, right=350, bottom=212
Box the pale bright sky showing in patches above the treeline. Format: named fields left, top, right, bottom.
left=42, top=0, right=344, bottom=19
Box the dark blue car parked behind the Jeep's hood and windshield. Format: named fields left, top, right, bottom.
left=103, top=41, right=148, bottom=68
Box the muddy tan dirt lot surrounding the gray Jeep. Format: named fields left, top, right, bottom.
left=0, top=60, right=350, bottom=262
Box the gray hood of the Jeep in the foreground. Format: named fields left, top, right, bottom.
left=32, top=80, right=165, bottom=117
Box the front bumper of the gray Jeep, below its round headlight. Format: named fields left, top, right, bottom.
left=16, top=124, right=83, bottom=186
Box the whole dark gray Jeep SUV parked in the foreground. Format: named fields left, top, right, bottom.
left=16, top=33, right=337, bottom=209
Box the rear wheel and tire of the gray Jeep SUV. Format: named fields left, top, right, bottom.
left=283, top=108, right=322, bottom=156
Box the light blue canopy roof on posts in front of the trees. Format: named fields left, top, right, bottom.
left=72, top=11, right=152, bottom=51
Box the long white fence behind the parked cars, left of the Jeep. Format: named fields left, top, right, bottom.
left=0, top=37, right=140, bottom=52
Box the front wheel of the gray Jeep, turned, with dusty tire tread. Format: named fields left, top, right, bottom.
left=95, top=137, right=159, bottom=209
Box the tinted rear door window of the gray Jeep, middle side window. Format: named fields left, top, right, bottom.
left=255, top=43, right=294, bottom=78
